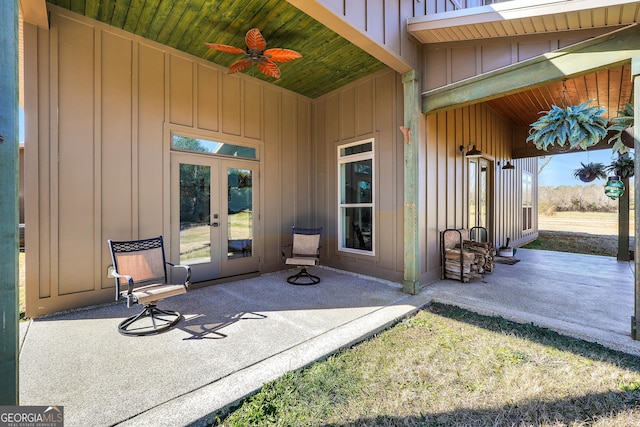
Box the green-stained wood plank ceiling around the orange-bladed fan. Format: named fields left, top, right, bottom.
left=49, top=0, right=384, bottom=98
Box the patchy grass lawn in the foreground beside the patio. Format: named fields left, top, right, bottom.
left=214, top=305, right=640, bottom=426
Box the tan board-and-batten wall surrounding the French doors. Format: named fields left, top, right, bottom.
left=24, top=5, right=314, bottom=317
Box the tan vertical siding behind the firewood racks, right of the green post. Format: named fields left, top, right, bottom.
left=421, top=104, right=537, bottom=283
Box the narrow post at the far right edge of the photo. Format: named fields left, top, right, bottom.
left=631, top=56, right=640, bottom=340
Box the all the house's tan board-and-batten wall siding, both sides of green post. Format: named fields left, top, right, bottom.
left=25, top=3, right=537, bottom=316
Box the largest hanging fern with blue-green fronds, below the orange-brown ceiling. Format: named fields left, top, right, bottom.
left=527, top=99, right=607, bottom=151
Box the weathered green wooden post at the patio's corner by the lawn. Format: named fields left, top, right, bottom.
left=400, top=70, right=421, bottom=295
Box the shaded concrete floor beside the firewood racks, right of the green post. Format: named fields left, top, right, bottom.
left=427, top=249, right=640, bottom=356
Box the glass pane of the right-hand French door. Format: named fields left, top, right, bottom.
left=227, top=168, right=253, bottom=259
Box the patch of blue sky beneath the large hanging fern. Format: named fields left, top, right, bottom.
left=538, top=149, right=632, bottom=187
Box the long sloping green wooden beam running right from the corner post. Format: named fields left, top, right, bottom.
left=422, top=25, right=640, bottom=114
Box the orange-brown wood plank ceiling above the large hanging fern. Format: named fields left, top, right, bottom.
left=488, top=64, right=633, bottom=126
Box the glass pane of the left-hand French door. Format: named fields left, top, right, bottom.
left=180, top=163, right=211, bottom=264
